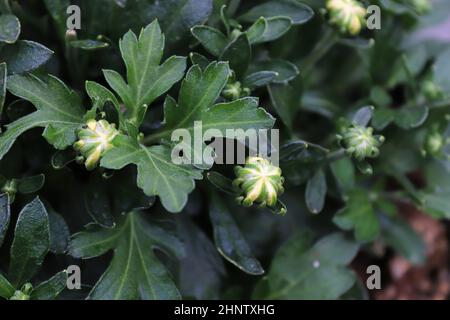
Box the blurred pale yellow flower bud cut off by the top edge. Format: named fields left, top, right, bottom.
left=326, top=0, right=366, bottom=36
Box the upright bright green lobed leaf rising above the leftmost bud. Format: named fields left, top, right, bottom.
left=104, top=20, right=186, bottom=125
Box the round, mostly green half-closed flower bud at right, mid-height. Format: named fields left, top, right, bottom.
left=337, top=124, right=385, bottom=161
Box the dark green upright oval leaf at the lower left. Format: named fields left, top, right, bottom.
left=9, top=197, right=50, bottom=288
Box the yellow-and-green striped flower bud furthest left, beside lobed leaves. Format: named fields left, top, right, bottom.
left=73, top=120, right=119, bottom=170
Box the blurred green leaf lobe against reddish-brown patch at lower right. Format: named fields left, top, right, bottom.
left=381, top=216, right=426, bottom=265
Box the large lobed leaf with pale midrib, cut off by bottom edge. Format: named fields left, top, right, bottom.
left=69, top=212, right=182, bottom=300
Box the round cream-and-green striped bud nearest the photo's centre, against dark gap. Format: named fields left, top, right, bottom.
left=233, top=157, right=284, bottom=207
